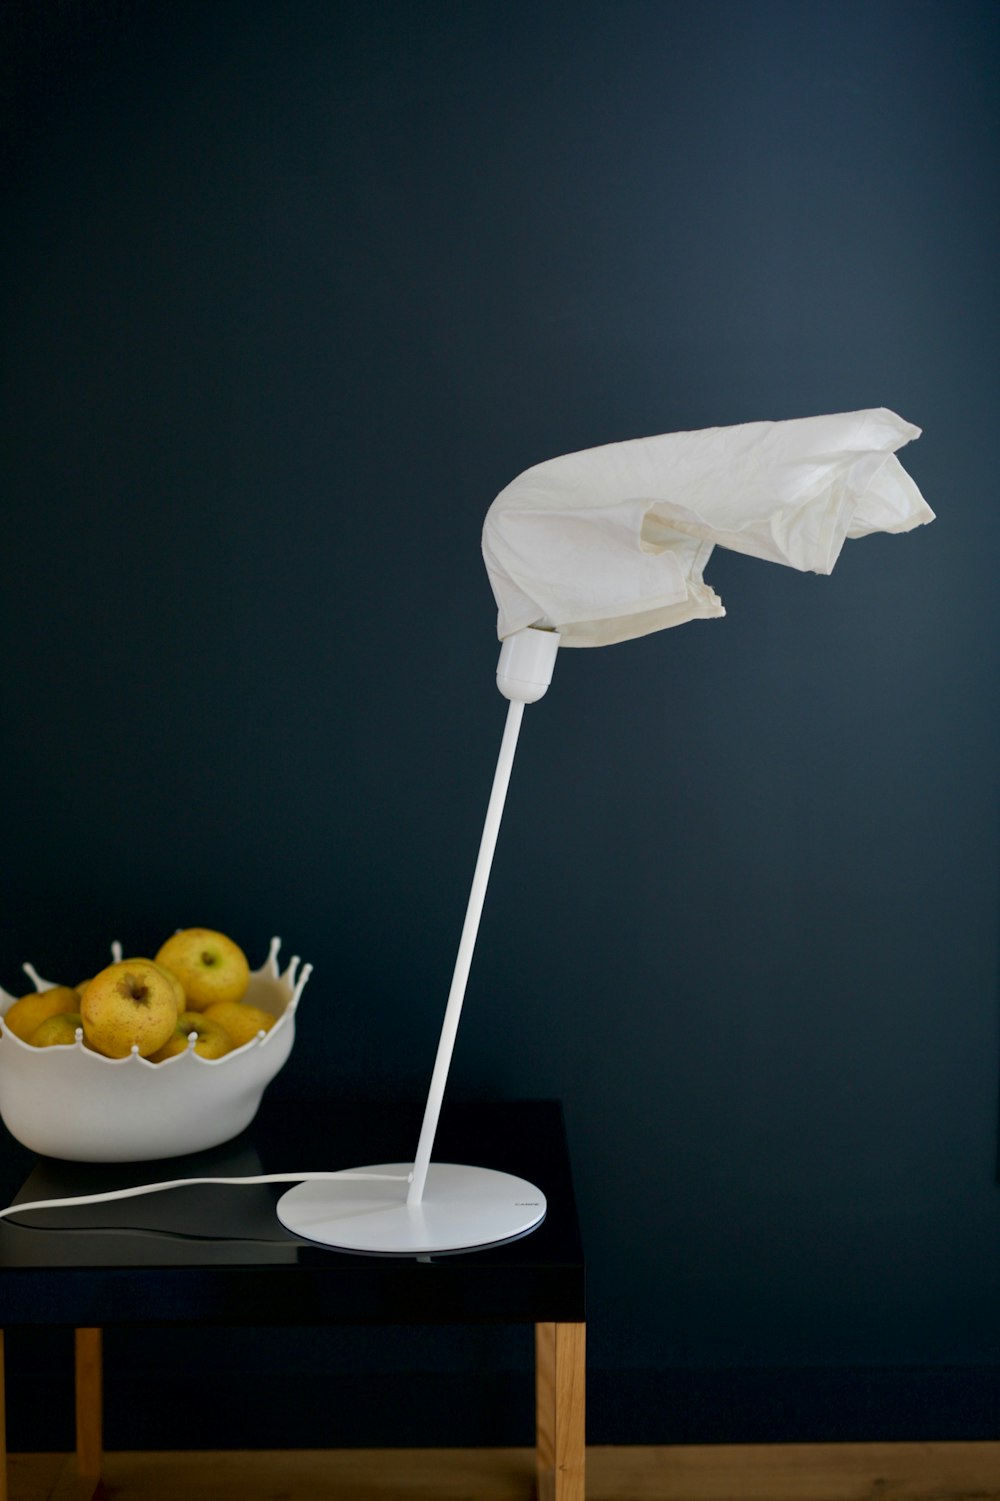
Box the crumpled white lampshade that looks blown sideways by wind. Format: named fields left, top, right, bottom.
left=482, top=407, right=934, bottom=647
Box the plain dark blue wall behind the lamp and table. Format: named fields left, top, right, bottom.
left=0, top=0, right=1000, bottom=1447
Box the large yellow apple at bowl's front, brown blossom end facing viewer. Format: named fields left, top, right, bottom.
left=80, top=959, right=177, bottom=1058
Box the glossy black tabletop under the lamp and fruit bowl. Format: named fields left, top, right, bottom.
left=0, top=1096, right=584, bottom=1327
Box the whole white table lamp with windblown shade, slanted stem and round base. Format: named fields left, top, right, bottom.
left=270, top=408, right=934, bottom=1255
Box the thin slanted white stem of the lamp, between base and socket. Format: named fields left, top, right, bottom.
left=407, top=699, right=524, bottom=1204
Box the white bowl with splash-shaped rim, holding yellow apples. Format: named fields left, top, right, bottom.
left=0, top=938, right=312, bottom=1162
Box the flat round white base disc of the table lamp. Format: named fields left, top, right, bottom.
left=278, top=1162, right=545, bottom=1256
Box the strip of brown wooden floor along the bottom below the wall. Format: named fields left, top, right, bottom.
left=9, top=1442, right=1000, bottom=1501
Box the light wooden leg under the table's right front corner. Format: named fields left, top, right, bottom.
left=535, top=1324, right=587, bottom=1501
